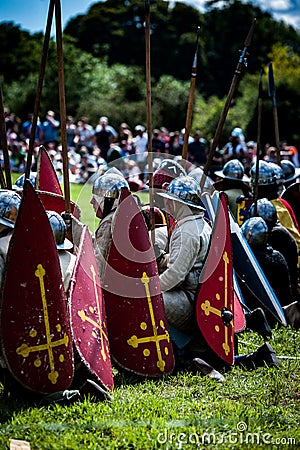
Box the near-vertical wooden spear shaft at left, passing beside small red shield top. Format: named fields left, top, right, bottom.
left=55, top=0, right=70, bottom=214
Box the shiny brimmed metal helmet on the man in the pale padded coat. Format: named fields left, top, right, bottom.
left=158, top=175, right=204, bottom=211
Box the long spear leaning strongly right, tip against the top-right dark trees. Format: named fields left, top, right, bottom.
left=200, top=19, right=256, bottom=189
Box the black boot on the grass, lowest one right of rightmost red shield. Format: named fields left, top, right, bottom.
left=235, top=342, right=281, bottom=370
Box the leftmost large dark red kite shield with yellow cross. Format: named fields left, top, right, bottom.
left=0, top=181, right=74, bottom=394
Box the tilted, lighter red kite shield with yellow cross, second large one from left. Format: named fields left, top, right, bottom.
left=69, top=226, right=114, bottom=389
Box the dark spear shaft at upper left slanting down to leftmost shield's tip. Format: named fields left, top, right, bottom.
left=25, top=0, right=54, bottom=178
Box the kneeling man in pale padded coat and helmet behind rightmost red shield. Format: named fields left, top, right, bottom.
left=159, top=176, right=278, bottom=374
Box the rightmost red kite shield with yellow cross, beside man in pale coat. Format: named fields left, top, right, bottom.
left=196, top=192, right=234, bottom=365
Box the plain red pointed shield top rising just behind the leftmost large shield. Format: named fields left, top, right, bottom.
left=36, top=145, right=63, bottom=195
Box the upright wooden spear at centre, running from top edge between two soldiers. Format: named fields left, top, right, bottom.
left=145, top=0, right=155, bottom=244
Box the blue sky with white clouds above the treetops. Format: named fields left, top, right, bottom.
left=0, top=0, right=300, bottom=33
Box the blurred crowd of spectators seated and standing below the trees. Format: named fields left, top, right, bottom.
left=0, top=109, right=300, bottom=187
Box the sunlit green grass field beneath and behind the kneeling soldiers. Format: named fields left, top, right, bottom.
left=0, top=178, right=300, bottom=450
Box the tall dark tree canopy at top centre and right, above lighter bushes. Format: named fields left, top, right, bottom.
left=65, top=0, right=300, bottom=98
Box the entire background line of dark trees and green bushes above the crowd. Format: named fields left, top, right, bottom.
left=0, top=0, right=300, bottom=145
